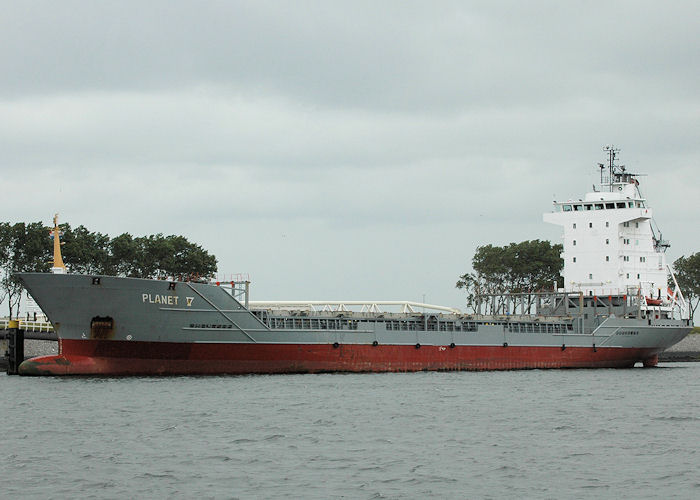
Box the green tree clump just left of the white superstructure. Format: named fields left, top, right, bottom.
left=456, top=240, right=564, bottom=308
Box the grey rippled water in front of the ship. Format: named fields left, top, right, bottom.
left=0, top=363, right=700, bottom=498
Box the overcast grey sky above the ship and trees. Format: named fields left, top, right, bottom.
left=0, top=0, right=700, bottom=308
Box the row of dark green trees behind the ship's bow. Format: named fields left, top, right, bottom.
left=0, top=222, right=217, bottom=317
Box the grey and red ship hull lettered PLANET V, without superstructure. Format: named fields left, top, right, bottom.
left=15, top=273, right=691, bottom=375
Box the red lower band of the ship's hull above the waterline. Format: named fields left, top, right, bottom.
left=19, top=339, right=660, bottom=375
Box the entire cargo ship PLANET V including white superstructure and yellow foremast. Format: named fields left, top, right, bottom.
left=19, top=147, right=691, bottom=376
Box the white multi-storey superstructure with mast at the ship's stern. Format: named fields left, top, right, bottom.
left=544, top=146, right=669, bottom=302
